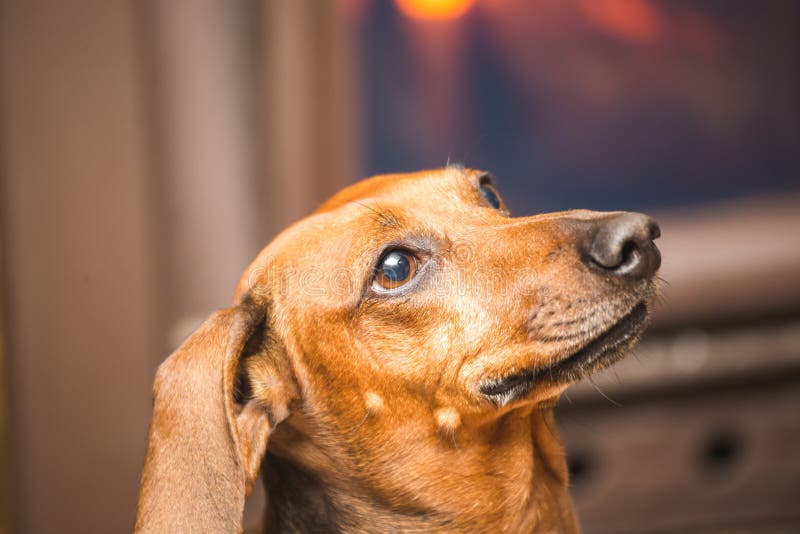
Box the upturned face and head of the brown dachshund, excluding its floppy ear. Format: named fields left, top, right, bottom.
left=238, top=168, right=660, bottom=416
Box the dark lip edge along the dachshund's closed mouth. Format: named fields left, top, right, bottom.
left=480, top=301, right=648, bottom=398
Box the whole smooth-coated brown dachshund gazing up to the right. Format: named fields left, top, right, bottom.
left=136, top=167, right=661, bottom=533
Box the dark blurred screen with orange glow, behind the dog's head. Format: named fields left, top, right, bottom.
left=352, top=0, right=800, bottom=214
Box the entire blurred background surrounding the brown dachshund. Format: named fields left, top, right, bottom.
left=0, top=0, right=800, bottom=533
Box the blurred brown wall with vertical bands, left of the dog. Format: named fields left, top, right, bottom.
left=0, top=0, right=356, bottom=533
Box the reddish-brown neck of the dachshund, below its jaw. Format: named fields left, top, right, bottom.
left=262, top=408, right=578, bottom=532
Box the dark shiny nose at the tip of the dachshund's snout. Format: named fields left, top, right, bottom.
left=584, top=213, right=661, bottom=279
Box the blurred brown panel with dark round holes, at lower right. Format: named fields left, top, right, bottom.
left=559, top=380, right=800, bottom=534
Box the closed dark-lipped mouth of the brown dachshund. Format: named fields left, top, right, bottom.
left=480, top=302, right=648, bottom=405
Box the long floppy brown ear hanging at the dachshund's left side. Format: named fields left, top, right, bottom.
left=136, top=299, right=296, bottom=532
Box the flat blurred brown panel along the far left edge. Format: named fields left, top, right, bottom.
left=0, top=0, right=160, bottom=533
